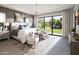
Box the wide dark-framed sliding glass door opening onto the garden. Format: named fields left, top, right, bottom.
left=38, top=16, right=62, bottom=35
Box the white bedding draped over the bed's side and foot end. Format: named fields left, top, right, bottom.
left=18, top=28, right=36, bottom=44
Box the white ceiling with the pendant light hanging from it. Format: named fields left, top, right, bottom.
left=0, top=4, right=75, bottom=15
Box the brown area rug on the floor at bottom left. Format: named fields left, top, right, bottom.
left=0, top=39, right=31, bottom=55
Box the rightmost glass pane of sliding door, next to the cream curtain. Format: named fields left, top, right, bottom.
left=53, top=16, right=62, bottom=35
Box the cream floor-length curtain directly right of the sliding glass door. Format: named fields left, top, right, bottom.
left=62, top=10, right=69, bottom=37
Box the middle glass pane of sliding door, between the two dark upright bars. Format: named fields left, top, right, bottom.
left=45, top=17, right=52, bottom=34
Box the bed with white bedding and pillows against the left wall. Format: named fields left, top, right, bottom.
left=12, top=23, right=36, bottom=44
